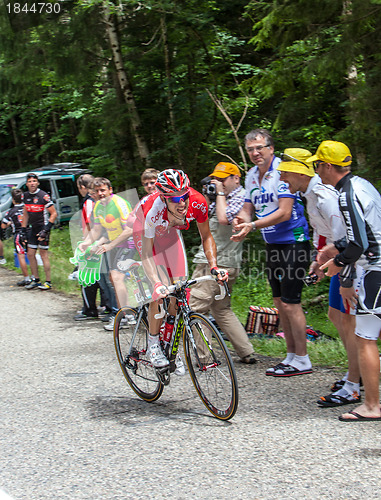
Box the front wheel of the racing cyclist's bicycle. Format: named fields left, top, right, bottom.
left=183, top=313, right=238, bottom=420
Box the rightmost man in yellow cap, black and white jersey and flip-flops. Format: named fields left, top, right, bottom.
left=310, top=141, right=381, bottom=422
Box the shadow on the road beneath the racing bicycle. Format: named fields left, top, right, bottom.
left=86, top=396, right=231, bottom=427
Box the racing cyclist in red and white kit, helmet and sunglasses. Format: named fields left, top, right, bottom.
left=134, top=169, right=228, bottom=368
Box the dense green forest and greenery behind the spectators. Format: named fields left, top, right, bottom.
left=0, top=0, right=381, bottom=362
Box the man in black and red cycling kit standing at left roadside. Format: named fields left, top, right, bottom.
left=20, top=173, right=57, bottom=290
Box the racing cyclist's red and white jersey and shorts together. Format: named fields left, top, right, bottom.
left=133, top=188, right=208, bottom=278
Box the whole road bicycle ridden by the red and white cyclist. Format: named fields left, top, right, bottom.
left=114, top=263, right=238, bottom=420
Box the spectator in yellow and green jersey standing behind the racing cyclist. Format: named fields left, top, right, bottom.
left=79, top=177, right=132, bottom=330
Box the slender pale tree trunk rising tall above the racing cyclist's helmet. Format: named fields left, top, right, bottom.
left=103, top=1, right=150, bottom=167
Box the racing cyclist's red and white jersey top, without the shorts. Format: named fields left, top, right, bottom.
left=141, top=188, right=208, bottom=238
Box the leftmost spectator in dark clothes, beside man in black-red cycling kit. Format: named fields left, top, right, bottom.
left=1, top=189, right=31, bottom=286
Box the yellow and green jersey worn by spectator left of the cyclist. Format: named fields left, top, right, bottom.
left=94, top=194, right=131, bottom=241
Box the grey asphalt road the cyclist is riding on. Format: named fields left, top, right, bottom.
left=0, top=268, right=381, bottom=500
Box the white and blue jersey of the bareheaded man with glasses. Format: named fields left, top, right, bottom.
left=245, top=158, right=309, bottom=244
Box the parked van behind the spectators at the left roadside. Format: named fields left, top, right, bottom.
left=0, top=163, right=89, bottom=224
